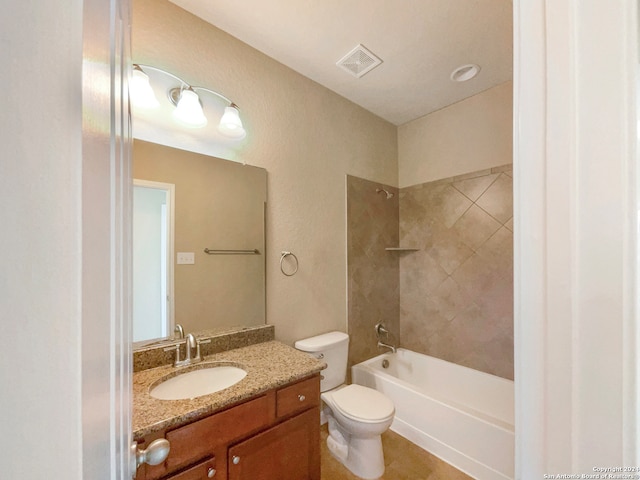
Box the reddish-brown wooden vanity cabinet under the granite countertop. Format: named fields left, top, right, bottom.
left=136, top=374, right=320, bottom=480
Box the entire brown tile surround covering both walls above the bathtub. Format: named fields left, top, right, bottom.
left=347, top=165, right=513, bottom=379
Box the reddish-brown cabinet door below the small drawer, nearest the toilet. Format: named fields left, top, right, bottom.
left=228, top=407, right=320, bottom=480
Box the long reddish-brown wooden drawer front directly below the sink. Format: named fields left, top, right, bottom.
left=165, top=396, right=269, bottom=471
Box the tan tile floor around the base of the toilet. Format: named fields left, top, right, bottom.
left=320, top=425, right=472, bottom=480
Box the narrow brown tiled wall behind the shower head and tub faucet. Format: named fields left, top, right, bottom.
left=347, top=175, right=400, bottom=366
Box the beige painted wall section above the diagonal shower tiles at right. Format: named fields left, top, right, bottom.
left=398, top=82, right=513, bottom=188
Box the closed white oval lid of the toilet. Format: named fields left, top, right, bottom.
left=332, top=384, right=395, bottom=422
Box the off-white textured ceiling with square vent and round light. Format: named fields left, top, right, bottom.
left=171, top=0, right=513, bottom=125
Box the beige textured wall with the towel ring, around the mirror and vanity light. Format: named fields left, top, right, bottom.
left=133, top=0, right=398, bottom=343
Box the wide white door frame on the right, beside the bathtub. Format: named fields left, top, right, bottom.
left=513, top=0, right=639, bottom=472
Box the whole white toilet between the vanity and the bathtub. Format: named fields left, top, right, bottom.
left=295, top=332, right=395, bottom=479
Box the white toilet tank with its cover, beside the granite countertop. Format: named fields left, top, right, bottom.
left=295, top=332, right=349, bottom=392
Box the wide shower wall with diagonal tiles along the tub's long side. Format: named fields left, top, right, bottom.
left=400, top=165, right=513, bottom=379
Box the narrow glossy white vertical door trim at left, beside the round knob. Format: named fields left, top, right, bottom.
left=82, top=0, right=133, bottom=480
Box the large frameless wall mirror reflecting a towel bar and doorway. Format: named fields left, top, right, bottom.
left=133, top=139, right=267, bottom=347
